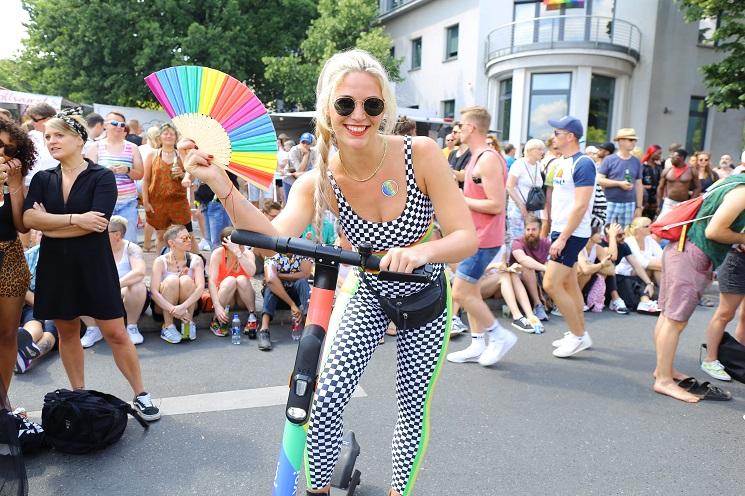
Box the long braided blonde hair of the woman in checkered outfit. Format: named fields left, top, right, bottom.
left=313, top=49, right=398, bottom=239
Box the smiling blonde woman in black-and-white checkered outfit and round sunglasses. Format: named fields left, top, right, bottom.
left=181, top=50, right=476, bottom=495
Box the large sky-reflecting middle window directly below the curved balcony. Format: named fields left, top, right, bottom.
left=528, top=72, right=572, bottom=140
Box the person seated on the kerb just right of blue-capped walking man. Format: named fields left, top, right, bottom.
left=577, top=225, right=615, bottom=312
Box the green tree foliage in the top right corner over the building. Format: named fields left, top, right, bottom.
left=677, top=0, right=745, bottom=111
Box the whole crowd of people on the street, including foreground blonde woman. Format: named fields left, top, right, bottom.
left=0, top=47, right=745, bottom=492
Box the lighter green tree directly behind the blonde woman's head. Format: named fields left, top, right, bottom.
left=264, top=0, right=401, bottom=108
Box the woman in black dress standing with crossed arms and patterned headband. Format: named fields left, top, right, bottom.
left=23, top=111, right=160, bottom=421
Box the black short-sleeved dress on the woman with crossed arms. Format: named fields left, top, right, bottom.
left=24, top=159, right=123, bottom=320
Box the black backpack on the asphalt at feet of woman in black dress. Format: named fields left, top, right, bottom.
left=41, top=389, right=149, bottom=454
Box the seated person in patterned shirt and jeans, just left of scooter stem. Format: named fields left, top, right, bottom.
left=259, top=253, right=313, bottom=351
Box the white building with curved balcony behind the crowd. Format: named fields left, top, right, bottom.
left=380, top=0, right=745, bottom=158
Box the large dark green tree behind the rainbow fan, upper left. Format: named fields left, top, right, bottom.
left=19, top=0, right=316, bottom=105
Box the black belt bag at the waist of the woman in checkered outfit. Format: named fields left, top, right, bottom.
left=360, top=270, right=447, bottom=330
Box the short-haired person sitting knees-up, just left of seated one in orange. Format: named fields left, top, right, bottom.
left=150, top=225, right=204, bottom=344
